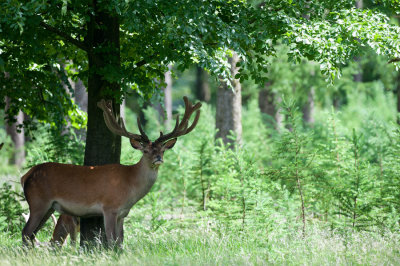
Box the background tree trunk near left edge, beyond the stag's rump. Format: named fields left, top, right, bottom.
left=5, top=97, right=25, bottom=167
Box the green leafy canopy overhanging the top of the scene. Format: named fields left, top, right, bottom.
left=0, top=0, right=400, bottom=129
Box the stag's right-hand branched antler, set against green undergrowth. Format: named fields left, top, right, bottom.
left=154, top=96, right=201, bottom=143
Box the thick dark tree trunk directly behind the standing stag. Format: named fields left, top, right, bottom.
left=80, top=1, right=121, bottom=246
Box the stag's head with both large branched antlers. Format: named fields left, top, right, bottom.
left=97, top=96, right=201, bottom=167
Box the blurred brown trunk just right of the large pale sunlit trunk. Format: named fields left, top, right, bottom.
left=258, top=82, right=283, bottom=130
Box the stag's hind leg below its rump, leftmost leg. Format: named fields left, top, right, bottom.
left=22, top=204, right=54, bottom=246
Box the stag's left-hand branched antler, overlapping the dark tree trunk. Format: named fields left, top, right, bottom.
left=97, top=99, right=150, bottom=143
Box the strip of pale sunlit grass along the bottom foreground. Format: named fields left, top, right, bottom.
left=0, top=222, right=400, bottom=265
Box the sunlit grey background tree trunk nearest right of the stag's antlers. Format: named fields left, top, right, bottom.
left=216, top=53, right=242, bottom=147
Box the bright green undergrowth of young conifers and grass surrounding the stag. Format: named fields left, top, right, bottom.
left=0, top=89, right=400, bottom=265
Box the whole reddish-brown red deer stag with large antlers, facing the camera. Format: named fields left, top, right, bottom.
left=21, top=97, right=201, bottom=245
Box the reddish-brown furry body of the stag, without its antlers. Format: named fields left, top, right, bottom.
left=21, top=147, right=170, bottom=244
